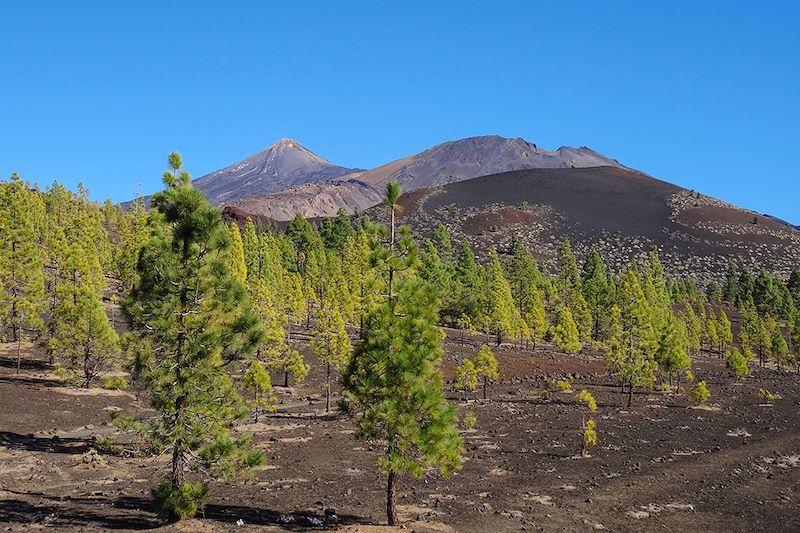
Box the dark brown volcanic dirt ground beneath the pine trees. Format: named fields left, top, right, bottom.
left=0, top=332, right=800, bottom=532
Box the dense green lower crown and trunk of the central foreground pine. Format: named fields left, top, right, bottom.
left=342, top=280, right=462, bottom=525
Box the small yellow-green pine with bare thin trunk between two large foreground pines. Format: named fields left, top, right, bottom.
left=311, top=291, right=352, bottom=413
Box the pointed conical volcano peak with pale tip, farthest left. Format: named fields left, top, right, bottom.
left=193, top=139, right=359, bottom=204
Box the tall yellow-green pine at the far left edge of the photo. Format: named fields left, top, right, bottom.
left=0, top=174, right=45, bottom=373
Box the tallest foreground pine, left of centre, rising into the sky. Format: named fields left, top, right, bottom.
left=125, top=153, right=263, bottom=520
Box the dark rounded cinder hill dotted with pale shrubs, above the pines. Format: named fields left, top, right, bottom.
left=368, top=167, right=800, bottom=280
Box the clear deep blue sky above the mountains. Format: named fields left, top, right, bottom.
left=0, top=0, right=800, bottom=223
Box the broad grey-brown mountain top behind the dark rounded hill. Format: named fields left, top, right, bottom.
left=358, top=135, right=621, bottom=191
